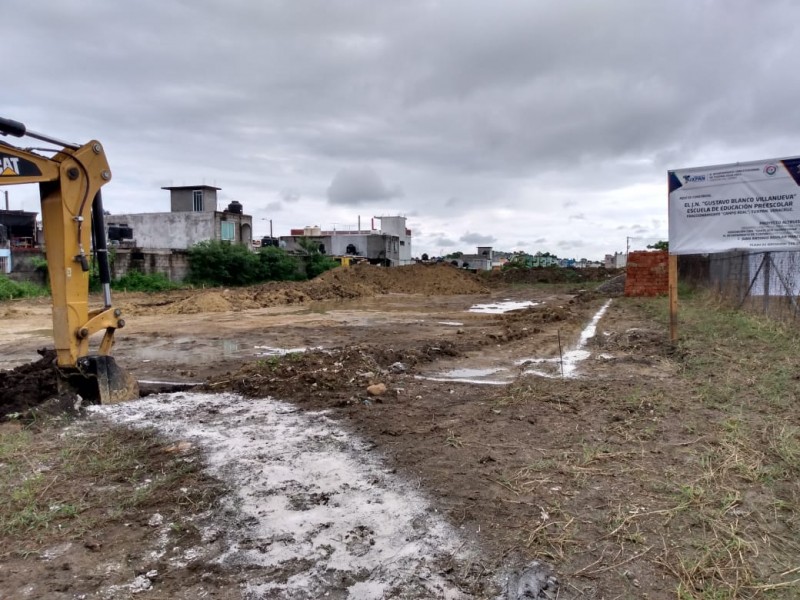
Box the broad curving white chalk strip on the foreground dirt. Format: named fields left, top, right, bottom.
left=92, top=392, right=482, bottom=600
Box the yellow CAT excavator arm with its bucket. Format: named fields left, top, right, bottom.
left=0, top=118, right=139, bottom=404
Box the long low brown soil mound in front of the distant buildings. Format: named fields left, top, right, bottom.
left=126, top=264, right=488, bottom=315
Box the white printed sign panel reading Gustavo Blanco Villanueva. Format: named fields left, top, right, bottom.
left=667, top=157, right=800, bottom=254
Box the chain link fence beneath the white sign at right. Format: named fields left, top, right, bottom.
left=678, top=251, right=800, bottom=322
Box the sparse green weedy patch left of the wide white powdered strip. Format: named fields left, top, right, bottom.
left=0, top=423, right=220, bottom=554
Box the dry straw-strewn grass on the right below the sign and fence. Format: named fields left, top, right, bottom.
left=493, top=290, right=800, bottom=600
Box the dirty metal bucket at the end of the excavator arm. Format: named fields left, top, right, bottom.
left=63, top=355, right=139, bottom=404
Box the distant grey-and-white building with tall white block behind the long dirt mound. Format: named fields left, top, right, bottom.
left=280, top=216, right=412, bottom=267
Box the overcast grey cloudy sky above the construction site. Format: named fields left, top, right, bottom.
left=0, top=0, right=800, bottom=259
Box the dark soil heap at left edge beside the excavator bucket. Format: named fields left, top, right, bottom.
left=0, top=350, right=78, bottom=421
